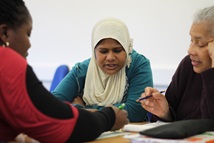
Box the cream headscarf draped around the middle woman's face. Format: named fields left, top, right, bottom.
left=83, top=18, right=132, bottom=106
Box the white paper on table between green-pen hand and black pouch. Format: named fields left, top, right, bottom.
left=123, top=121, right=169, bottom=132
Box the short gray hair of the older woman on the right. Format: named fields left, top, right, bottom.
left=193, top=5, right=214, bottom=36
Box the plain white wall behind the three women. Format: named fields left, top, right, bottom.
left=25, top=0, right=213, bottom=89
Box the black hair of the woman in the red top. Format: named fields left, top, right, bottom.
left=0, top=0, right=30, bottom=29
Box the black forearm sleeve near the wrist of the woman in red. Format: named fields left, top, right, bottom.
left=69, top=107, right=115, bottom=142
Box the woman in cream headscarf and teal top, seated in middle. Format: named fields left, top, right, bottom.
left=53, top=18, right=153, bottom=122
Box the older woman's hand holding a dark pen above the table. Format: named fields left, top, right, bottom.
left=139, top=87, right=171, bottom=121
